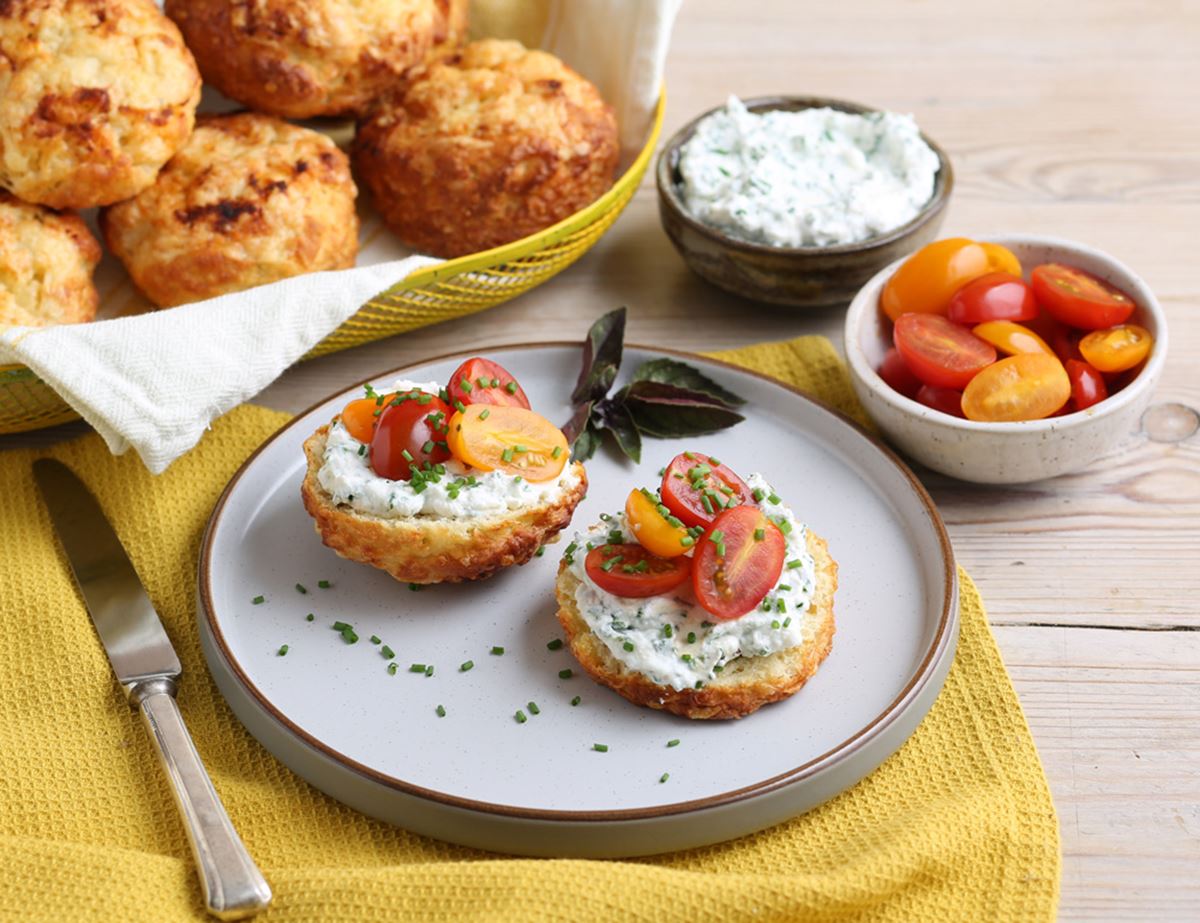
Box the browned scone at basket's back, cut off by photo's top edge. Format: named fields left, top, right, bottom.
left=166, top=0, right=448, bottom=119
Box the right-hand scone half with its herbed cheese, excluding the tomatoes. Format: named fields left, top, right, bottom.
left=556, top=474, right=838, bottom=719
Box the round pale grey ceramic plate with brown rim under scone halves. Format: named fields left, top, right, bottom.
left=199, top=344, right=958, bottom=856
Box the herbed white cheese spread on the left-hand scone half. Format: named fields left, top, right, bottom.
left=317, top=380, right=580, bottom=520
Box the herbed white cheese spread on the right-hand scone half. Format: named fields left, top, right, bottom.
left=564, top=474, right=816, bottom=690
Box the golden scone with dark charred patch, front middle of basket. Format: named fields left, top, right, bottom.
left=101, top=113, right=359, bottom=307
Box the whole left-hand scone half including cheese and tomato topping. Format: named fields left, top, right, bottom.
left=301, top=358, right=587, bottom=583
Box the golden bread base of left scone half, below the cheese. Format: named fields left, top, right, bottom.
left=300, top=426, right=588, bottom=583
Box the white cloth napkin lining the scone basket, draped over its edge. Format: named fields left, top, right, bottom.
left=0, top=0, right=682, bottom=473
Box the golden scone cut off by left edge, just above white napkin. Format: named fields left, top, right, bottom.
left=0, top=190, right=100, bottom=326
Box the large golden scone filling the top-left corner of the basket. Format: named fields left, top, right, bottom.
left=0, top=0, right=200, bottom=209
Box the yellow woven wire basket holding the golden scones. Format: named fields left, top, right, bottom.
left=0, top=95, right=666, bottom=434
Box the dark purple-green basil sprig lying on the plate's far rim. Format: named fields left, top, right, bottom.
left=563, top=307, right=745, bottom=462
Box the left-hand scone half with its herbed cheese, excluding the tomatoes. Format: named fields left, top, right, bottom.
left=300, top=382, right=588, bottom=585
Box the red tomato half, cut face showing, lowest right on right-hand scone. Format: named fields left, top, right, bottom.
left=691, top=507, right=787, bottom=619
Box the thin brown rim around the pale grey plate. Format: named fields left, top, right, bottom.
left=197, top=340, right=958, bottom=822
